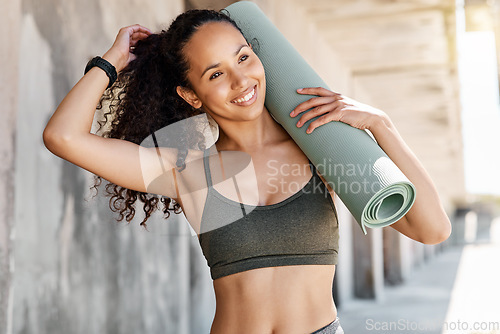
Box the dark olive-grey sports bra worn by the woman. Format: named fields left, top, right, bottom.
left=199, top=149, right=339, bottom=280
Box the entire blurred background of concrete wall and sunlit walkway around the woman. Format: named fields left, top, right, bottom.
left=0, top=0, right=500, bottom=334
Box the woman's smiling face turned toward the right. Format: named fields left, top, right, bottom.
left=181, top=22, right=266, bottom=121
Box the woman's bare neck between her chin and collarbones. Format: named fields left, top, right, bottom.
left=211, top=107, right=290, bottom=153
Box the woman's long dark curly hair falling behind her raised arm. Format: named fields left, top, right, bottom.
left=91, top=9, right=243, bottom=230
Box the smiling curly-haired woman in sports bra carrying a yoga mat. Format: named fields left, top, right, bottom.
left=43, top=10, right=451, bottom=334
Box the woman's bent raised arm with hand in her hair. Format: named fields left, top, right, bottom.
left=43, top=24, right=178, bottom=199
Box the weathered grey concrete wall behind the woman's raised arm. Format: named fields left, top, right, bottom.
left=7, top=0, right=215, bottom=334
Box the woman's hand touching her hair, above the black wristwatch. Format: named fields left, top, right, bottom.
left=102, top=24, right=152, bottom=72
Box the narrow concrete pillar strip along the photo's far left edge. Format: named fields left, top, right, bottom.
left=0, top=0, right=21, bottom=333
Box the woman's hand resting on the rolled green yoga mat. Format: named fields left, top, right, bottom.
left=290, top=87, right=388, bottom=133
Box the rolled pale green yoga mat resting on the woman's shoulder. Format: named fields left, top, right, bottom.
left=222, top=1, right=416, bottom=234
